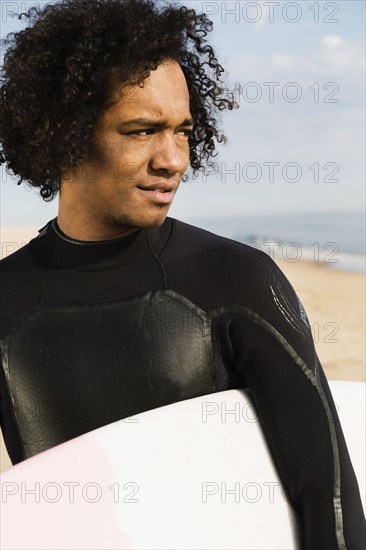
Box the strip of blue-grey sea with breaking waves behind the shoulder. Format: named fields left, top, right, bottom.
left=187, top=211, right=366, bottom=273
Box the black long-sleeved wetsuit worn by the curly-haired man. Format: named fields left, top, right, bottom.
left=0, top=217, right=365, bottom=550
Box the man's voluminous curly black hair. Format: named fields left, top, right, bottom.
left=0, top=0, right=238, bottom=200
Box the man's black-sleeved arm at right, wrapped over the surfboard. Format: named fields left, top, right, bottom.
left=216, top=257, right=366, bottom=550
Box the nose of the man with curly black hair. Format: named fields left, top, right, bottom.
left=150, top=131, right=189, bottom=175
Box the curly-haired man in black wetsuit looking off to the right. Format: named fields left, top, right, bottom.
left=0, top=0, right=364, bottom=550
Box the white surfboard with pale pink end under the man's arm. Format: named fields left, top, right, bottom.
left=0, top=382, right=366, bottom=550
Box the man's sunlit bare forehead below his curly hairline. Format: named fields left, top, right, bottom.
left=103, top=61, right=190, bottom=123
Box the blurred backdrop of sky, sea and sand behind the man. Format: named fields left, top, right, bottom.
left=0, top=0, right=365, bottom=472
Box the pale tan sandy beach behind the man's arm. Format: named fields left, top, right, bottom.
left=0, top=245, right=366, bottom=470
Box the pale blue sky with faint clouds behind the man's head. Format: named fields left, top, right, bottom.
left=0, top=0, right=365, bottom=230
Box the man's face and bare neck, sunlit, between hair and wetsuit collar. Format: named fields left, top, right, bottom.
left=60, top=61, right=193, bottom=238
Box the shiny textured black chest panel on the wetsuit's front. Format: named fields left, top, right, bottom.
left=2, top=290, right=215, bottom=457
